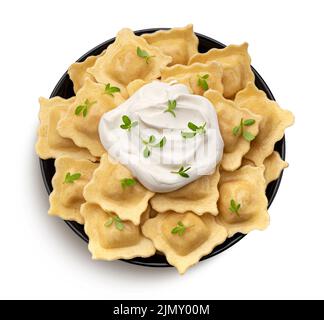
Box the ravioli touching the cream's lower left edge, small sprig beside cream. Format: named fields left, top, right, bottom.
left=84, top=154, right=154, bottom=225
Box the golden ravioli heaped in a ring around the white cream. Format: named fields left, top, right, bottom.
left=36, top=25, right=294, bottom=274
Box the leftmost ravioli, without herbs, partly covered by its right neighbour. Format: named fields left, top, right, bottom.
left=36, top=97, right=96, bottom=161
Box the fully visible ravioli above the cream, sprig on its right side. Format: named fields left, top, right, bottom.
left=88, top=29, right=172, bottom=98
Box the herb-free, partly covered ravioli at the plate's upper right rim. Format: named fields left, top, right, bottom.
left=189, top=43, right=254, bottom=99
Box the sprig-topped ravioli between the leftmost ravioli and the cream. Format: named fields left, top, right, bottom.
left=57, top=79, right=124, bottom=157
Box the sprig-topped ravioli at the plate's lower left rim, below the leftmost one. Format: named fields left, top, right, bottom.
left=48, top=157, right=98, bottom=224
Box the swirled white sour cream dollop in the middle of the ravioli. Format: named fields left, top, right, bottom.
left=99, top=81, right=224, bottom=192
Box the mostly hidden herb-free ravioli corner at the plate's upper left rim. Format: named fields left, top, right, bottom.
left=68, top=51, right=105, bottom=93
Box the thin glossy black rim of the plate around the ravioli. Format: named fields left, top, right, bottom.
left=39, top=28, right=286, bottom=267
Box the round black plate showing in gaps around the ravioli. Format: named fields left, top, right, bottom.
left=40, top=28, right=285, bottom=267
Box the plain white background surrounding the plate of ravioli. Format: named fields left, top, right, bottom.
left=0, top=0, right=324, bottom=299
